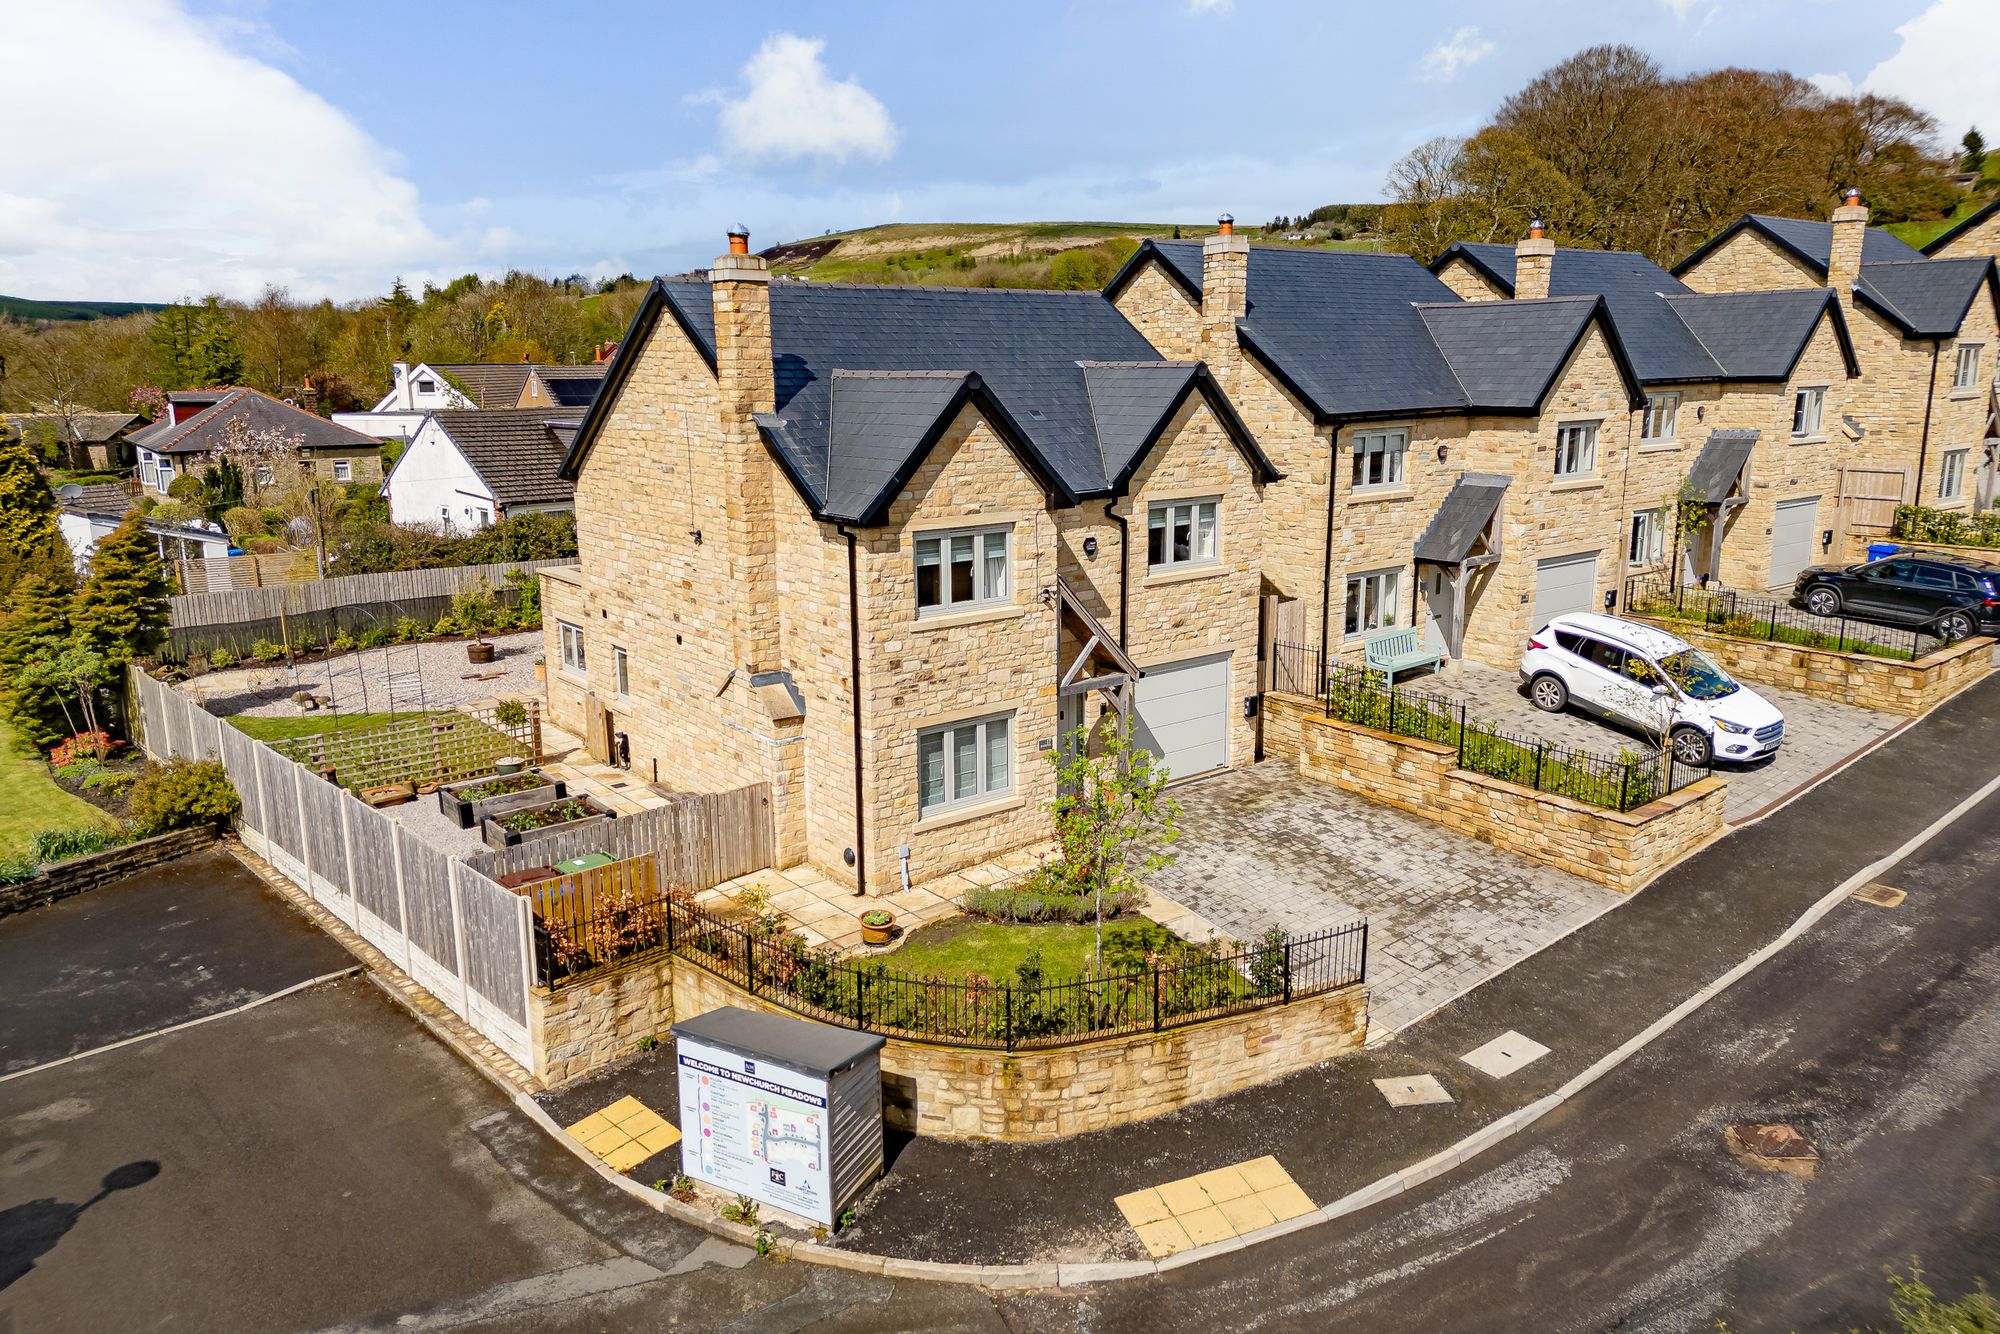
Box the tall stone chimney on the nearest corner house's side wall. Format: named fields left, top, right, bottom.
left=708, top=226, right=778, bottom=672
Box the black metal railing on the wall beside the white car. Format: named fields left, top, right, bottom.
left=1326, top=668, right=1708, bottom=810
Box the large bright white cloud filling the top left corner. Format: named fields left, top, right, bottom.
left=0, top=0, right=440, bottom=300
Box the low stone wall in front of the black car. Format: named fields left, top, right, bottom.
left=1634, top=616, right=1994, bottom=718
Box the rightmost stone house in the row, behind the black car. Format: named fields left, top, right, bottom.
left=1674, top=192, right=2000, bottom=508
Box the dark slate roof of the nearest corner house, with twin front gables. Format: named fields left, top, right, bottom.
left=564, top=280, right=1278, bottom=524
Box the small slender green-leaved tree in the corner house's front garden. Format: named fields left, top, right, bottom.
left=1048, top=728, right=1180, bottom=968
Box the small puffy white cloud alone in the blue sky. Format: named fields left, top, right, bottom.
left=698, top=32, right=896, bottom=162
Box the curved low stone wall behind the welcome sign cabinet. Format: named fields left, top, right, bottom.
left=674, top=964, right=1368, bottom=1142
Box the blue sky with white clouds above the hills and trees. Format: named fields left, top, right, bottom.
left=0, top=0, right=2000, bottom=298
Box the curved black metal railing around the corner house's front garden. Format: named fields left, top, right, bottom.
left=534, top=894, right=1368, bottom=1052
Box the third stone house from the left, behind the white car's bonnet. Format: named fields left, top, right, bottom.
left=1432, top=238, right=1860, bottom=590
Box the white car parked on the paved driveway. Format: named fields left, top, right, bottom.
left=1520, top=612, right=1784, bottom=764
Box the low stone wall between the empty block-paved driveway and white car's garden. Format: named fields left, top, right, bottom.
left=1266, top=716, right=1728, bottom=894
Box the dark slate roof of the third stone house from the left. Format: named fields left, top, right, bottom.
left=1432, top=242, right=1858, bottom=384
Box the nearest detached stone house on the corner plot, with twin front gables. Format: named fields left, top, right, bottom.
left=544, top=234, right=1278, bottom=892
